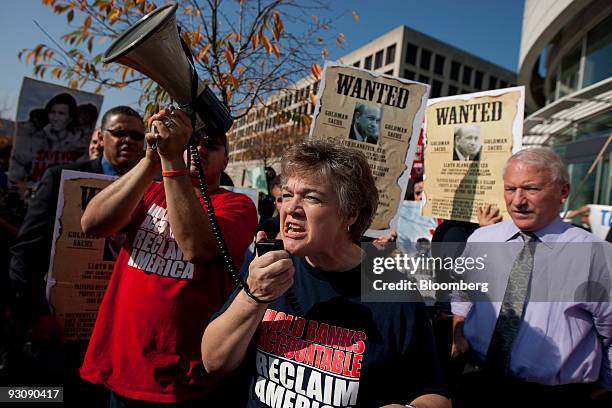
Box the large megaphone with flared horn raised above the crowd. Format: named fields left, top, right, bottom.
left=102, top=3, right=234, bottom=138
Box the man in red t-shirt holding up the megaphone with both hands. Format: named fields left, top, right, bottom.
left=81, top=109, right=257, bottom=406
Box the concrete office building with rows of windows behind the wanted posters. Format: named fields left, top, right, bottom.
left=228, top=26, right=517, bottom=185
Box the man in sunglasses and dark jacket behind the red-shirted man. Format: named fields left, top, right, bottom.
left=9, top=106, right=144, bottom=401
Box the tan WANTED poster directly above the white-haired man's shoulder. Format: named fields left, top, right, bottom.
left=423, top=87, right=524, bottom=223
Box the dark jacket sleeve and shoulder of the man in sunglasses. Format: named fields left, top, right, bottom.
left=9, top=158, right=103, bottom=317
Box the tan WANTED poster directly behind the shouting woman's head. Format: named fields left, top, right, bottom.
left=310, top=62, right=429, bottom=237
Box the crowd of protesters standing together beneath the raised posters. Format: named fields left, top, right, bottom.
left=0, top=101, right=612, bottom=408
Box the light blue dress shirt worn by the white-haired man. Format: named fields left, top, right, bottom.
left=452, top=218, right=612, bottom=390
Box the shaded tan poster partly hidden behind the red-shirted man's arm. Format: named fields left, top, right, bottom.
left=47, top=170, right=120, bottom=340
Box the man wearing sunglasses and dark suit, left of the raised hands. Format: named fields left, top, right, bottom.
left=9, top=106, right=145, bottom=402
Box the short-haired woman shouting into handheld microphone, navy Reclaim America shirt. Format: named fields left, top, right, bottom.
left=202, top=140, right=450, bottom=408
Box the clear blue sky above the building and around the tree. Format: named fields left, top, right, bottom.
left=0, top=0, right=524, bottom=119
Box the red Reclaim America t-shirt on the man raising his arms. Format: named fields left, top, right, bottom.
left=81, top=182, right=257, bottom=402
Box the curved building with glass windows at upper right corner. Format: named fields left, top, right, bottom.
left=519, top=0, right=612, bottom=209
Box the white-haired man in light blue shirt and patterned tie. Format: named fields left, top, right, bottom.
left=452, top=148, right=612, bottom=408
